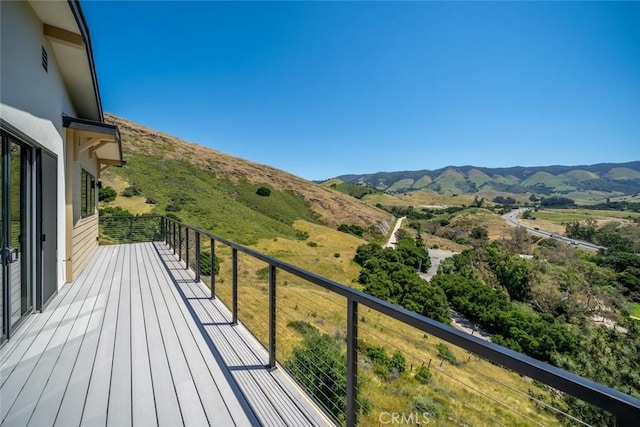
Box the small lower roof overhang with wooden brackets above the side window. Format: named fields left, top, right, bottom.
left=62, top=116, right=122, bottom=170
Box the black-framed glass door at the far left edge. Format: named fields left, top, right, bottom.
left=2, top=134, right=33, bottom=338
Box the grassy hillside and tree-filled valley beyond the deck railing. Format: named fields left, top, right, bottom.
left=100, top=116, right=640, bottom=425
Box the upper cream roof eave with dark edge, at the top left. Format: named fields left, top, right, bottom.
left=29, top=0, right=104, bottom=122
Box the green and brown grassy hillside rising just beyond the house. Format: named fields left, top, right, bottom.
left=102, top=115, right=393, bottom=243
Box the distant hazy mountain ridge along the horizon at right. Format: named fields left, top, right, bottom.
left=335, top=161, right=640, bottom=200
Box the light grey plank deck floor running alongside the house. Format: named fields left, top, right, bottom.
left=0, top=243, right=331, bottom=426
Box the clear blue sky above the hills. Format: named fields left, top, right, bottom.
left=82, top=1, right=640, bottom=180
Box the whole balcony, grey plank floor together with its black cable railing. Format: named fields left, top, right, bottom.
left=0, top=217, right=640, bottom=426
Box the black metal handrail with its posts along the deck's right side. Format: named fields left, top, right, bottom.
left=110, top=217, right=640, bottom=426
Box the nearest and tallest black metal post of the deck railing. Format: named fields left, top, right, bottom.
left=345, top=298, right=358, bottom=427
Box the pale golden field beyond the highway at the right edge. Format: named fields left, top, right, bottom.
left=520, top=209, right=640, bottom=234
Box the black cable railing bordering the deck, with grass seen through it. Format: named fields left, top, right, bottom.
left=100, top=217, right=640, bottom=426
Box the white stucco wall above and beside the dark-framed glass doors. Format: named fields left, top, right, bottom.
left=0, top=1, right=76, bottom=286
